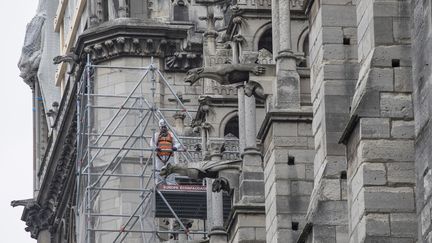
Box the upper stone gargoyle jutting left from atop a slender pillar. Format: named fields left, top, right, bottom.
left=184, top=64, right=266, bottom=85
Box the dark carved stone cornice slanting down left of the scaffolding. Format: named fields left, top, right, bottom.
left=11, top=66, right=77, bottom=239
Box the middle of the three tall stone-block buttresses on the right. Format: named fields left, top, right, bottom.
left=307, top=0, right=358, bottom=239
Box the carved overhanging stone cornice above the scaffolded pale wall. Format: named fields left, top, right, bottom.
left=75, top=19, right=202, bottom=72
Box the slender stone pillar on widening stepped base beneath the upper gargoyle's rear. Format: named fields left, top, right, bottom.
left=229, top=91, right=265, bottom=243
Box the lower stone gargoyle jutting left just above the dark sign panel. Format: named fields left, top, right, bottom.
left=159, top=160, right=241, bottom=192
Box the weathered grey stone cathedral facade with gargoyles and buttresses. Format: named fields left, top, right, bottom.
left=12, top=0, right=432, bottom=243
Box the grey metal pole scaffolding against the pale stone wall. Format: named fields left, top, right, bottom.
left=76, top=57, right=206, bottom=243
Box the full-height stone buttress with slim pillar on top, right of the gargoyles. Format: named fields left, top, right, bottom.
left=259, top=0, right=314, bottom=243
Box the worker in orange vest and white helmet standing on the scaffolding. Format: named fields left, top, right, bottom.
left=152, top=119, right=180, bottom=185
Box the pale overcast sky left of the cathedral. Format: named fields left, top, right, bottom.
left=0, top=0, right=38, bottom=243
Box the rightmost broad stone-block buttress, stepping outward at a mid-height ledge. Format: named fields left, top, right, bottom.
left=344, top=0, right=417, bottom=242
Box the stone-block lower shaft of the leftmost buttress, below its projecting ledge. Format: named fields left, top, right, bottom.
left=264, top=117, right=314, bottom=243
